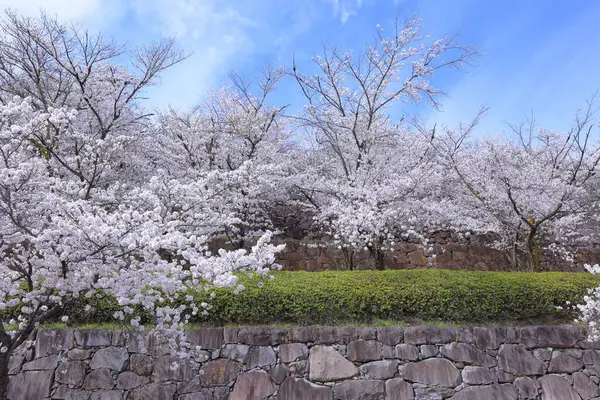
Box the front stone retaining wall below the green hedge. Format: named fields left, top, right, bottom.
left=8, top=326, right=600, bottom=400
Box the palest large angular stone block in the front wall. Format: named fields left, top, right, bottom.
left=309, top=346, right=358, bottom=382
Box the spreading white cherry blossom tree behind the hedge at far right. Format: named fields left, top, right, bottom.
left=428, top=96, right=600, bottom=271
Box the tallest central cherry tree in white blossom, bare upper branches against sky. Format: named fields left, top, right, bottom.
left=291, top=19, right=478, bottom=269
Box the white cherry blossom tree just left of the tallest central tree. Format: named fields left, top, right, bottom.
left=158, top=66, right=290, bottom=248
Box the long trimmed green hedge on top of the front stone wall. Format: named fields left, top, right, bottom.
left=70, top=270, right=600, bottom=325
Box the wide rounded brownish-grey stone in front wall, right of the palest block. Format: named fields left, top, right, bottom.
left=403, top=358, right=462, bottom=387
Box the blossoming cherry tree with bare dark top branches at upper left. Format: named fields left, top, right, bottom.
left=0, top=12, right=185, bottom=198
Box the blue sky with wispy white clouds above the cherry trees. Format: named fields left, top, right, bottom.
left=0, top=0, right=600, bottom=135
